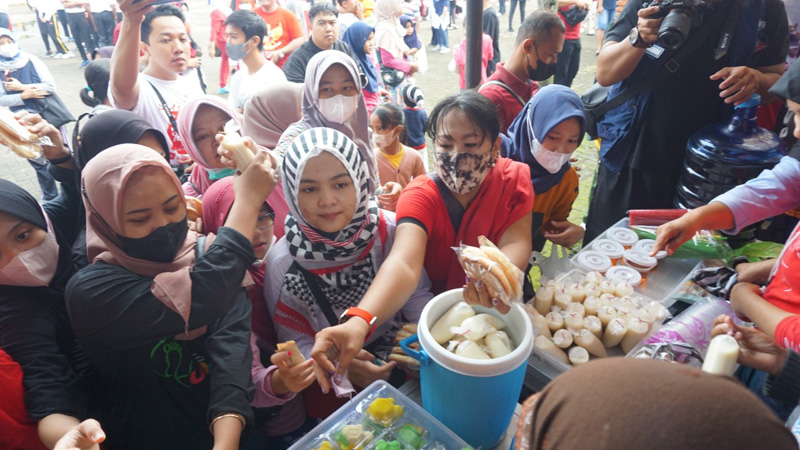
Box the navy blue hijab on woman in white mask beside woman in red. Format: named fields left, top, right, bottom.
left=503, top=84, right=586, bottom=195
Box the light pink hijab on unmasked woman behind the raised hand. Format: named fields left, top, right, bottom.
left=177, top=95, right=242, bottom=196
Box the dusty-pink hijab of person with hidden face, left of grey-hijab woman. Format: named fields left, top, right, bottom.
left=244, top=81, right=303, bottom=149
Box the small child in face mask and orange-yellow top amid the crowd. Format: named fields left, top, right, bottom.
left=369, top=103, right=425, bottom=211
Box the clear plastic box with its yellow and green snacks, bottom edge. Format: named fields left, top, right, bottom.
left=289, top=381, right=471, bottom=450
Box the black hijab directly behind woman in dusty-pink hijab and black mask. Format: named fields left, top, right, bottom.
left=75, top=109, right=169, bottom=171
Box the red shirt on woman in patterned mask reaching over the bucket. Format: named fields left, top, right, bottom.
left=397, top=158, right=533, bottom=294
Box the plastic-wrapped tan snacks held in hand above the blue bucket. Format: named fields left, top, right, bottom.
left=453, top=236, right=524, bottom=305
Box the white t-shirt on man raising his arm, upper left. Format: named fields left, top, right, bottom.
left=108, top=73, right=203, bottom=165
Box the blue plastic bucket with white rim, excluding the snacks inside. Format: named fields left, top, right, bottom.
left=400, top=289, right=533, bottom=449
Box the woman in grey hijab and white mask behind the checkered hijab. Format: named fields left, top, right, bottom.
left=275, top=50, right=378, bottom=192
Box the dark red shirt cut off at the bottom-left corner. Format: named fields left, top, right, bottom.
left=0, top=349, right=47, bottom=450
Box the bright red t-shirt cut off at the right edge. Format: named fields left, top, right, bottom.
left=764, top=228, right=800, bottom=351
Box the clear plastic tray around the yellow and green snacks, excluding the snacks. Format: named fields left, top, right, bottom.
left=289, top=381, right=471, bottom=450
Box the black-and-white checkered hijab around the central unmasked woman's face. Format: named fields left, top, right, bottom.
left=282, top=128, right=382, bottom=315
